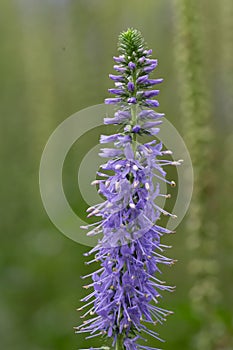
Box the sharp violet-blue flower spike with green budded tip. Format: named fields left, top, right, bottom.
left=76, top=29, right=181, bottom=350
